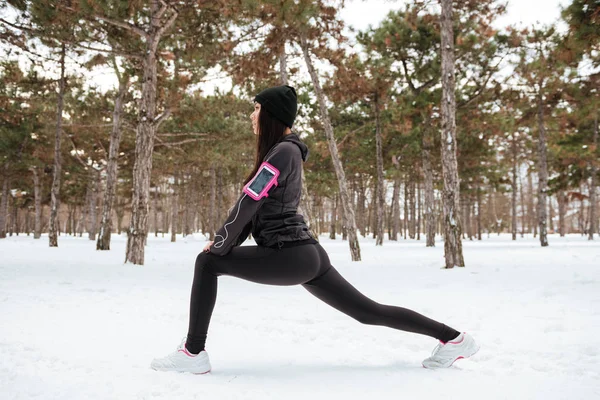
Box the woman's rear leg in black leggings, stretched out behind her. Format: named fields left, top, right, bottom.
left=302, top=245, right=459, bottom=343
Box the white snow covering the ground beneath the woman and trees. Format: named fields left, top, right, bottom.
left=0, top=235, right=600, bottom=400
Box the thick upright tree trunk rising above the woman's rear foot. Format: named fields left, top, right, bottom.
left=441, top=0, right=465, bottom=268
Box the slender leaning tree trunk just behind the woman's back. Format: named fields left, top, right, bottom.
left=300, top=35, right=361, bottom=261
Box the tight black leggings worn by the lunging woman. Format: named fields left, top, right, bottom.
left=186, top=244, right=459, bottom=354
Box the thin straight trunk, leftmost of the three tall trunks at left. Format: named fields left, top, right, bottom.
left=48, top=43, right=66, bottom=247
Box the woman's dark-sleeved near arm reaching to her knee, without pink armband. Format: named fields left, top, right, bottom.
left=210, top=142, right=298, bottom=256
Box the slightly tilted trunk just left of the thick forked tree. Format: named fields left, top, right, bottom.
left=96, top=70, right=129, bottom=250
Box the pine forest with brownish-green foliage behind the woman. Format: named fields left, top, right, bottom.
left=0, top=0, right=600, bottom=267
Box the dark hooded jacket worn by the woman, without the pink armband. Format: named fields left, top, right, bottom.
left=210, top=133, right=314, bottom=256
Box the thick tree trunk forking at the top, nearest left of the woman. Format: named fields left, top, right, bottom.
left=125, top=0, right=177, bottom=265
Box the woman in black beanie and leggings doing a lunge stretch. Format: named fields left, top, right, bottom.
left=151, top=86, right=479, bottom=374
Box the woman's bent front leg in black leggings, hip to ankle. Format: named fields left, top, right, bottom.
left=186, top=245, right=319, bottom=354
